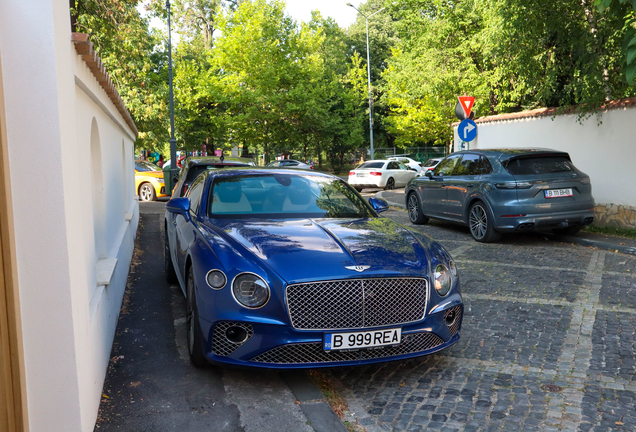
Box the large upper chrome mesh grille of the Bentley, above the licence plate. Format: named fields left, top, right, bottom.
left=285, top=278, right=427, bottom=330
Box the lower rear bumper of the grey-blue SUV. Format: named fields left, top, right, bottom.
left=496, top=210, right=594, bottom=232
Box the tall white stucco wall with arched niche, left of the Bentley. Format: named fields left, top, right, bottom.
left=0, top=0, right=139, bottom=432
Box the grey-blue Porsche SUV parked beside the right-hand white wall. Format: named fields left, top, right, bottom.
left=404, top=149, right=594, bottom=243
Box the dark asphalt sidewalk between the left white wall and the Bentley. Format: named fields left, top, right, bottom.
left=95, top=207, right=346, bottom=432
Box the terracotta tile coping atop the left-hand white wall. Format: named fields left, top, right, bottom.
left=71, top=33, right=139, bottom=137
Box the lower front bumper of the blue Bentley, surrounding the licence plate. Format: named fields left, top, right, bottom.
left=200, top=297, right=463, bottom=369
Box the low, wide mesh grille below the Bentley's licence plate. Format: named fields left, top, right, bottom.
left=252, top=333, right=444, bottom=364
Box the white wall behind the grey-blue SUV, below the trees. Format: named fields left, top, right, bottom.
left=454, top=107, right=636, bottom=207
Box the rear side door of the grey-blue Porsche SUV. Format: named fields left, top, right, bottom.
left=444, top=153, right=481, bottom=220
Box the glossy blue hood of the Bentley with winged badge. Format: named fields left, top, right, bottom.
left=214, top=218, right=428, bottom=283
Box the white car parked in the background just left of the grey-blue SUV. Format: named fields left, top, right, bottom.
left=349, top=160, right=417, bottom=192
